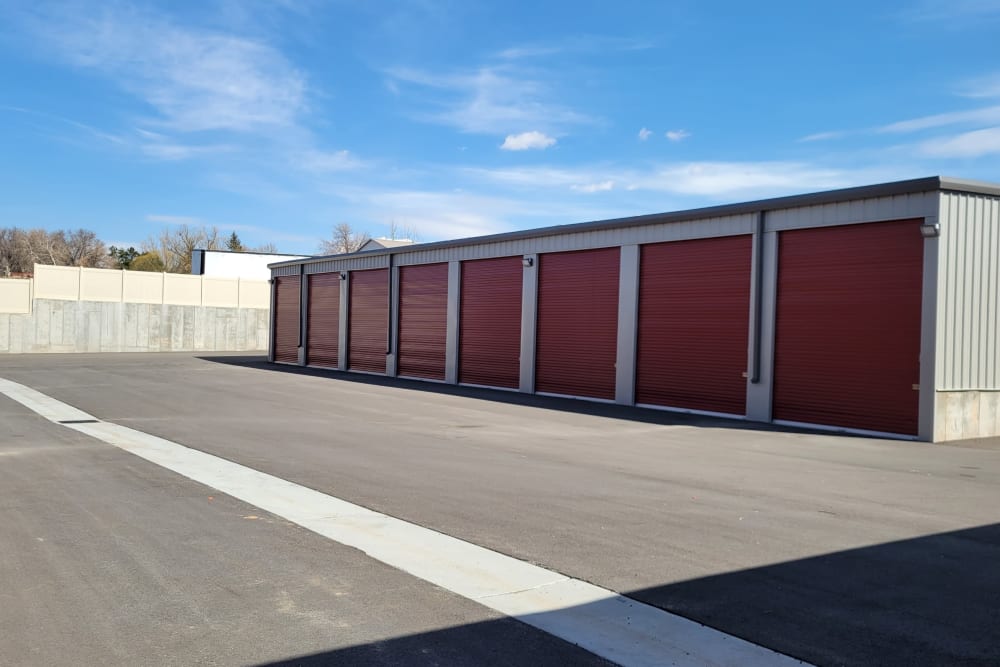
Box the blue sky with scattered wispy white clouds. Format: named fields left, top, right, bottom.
left=0, top=0, right=1000, bottom=253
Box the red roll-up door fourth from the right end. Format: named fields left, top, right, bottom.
left=458, top=257, right=524, bottom=389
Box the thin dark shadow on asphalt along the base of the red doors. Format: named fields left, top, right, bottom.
left=197, top=355, right=876, bottom=440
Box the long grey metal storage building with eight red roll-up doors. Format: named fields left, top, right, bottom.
left=269, top=177, right=1000, bottom=441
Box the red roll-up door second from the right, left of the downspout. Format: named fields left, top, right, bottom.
left=635, top=236, right=752, bottom=415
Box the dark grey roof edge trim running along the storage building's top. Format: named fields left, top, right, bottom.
left=268, top=176, right=1000, bottom=268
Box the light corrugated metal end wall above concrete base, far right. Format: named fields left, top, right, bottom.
left=937, top=192, right=1000, bottom=391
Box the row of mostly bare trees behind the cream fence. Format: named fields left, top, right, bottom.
left=0, top=225, right=277, bottom=277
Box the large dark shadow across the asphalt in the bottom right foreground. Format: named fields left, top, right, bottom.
left=256, top=524, right=1000, bottom=667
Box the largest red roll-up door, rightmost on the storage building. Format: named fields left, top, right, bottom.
left=773, top=220, right=924, bottom=435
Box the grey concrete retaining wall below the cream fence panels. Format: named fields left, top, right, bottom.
left=0, top=299, right=269, bottom=354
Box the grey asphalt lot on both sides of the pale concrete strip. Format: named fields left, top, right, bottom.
left=0, top=354, right=1000, bottom=665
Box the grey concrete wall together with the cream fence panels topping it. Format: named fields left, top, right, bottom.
left=0, top=264, right=271, bottom=354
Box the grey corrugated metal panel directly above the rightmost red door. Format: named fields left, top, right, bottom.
left=765, top=191, right=938, bottom=232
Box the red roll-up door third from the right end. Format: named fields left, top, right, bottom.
left=535, top=248, right=621, bottom=400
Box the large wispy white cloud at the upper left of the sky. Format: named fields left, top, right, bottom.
left=25, top=5, right=306, bottom=132
